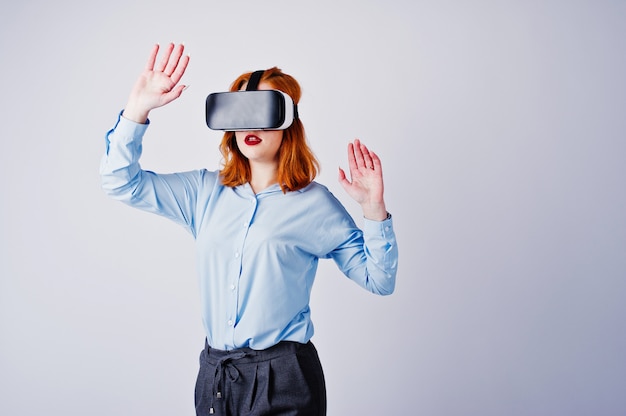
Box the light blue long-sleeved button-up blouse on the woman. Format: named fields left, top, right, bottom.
left=100, top=112, right=398, bottom=350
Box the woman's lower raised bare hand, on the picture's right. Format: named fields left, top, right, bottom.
left=339, top=139, right=387, bottom=221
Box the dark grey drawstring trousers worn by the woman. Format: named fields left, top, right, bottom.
left=195, top=341, right=326, bottom=416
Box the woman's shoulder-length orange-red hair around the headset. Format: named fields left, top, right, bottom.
left=220, top=67, right=319, bottom=193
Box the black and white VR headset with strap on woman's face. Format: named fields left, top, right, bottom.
left=205, top=71, right=298, bottom=131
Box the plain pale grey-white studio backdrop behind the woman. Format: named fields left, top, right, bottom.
left=0, top=0, right=626, bottom=416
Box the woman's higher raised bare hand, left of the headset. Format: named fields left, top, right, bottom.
left=122, top=43, right=189, bottom=124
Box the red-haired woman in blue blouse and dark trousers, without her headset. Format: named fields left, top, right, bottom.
left=101, top=44, right=397, bottom=415
